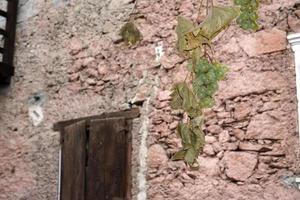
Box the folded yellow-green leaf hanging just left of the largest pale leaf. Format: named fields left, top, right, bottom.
left=176, top=16, right=194, bottom=52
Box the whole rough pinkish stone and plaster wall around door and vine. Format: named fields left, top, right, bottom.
left=0, top=0, right=300, bottom=200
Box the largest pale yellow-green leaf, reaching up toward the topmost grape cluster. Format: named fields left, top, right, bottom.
left=193, top=6, right=240, bottom=40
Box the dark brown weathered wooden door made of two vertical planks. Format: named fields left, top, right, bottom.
left=61, top=113, right=132, bottom=200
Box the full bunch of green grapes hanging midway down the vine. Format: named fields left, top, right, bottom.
left=193, top=58, right=228, bottom=108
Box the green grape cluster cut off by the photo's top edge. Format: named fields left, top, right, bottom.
left=234, top=0, right=259, bottom=30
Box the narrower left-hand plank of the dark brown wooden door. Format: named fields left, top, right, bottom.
left=61, top=121, right=86, bottom=200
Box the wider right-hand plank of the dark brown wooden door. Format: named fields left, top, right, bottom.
left=85, top=117, right=128, bottom=200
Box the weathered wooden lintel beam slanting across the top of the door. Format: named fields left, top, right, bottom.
left=53, top=108, right=140, bottom=131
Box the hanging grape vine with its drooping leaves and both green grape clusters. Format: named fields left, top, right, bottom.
left=170, top=0, right=259, bottom=168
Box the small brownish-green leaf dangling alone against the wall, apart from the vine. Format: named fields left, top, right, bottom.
left=120, top=22, right=142, bottom=45
